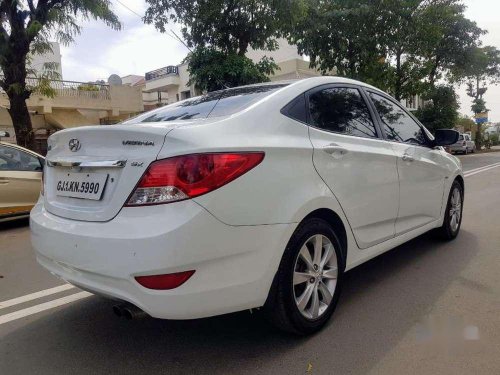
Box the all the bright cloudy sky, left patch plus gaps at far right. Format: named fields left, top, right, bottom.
left=61, top=0, right=500, bottom=122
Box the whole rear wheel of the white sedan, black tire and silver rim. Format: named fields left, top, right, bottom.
left=264, top=218, right=345, bottom=335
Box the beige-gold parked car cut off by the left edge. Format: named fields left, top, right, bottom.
left=0, top=134, right=45, bottom=222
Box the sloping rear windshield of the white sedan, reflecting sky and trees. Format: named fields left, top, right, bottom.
left=124, top=84, right=287, bottom=124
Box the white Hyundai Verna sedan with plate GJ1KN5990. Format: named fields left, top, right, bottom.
left=31, top=77, right=464, bottom=334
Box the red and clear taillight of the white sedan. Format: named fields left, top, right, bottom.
left=125, top=152, right=264, bottom=206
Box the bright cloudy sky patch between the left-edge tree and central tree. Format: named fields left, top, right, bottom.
left=61, top=0, right=188, bottom=82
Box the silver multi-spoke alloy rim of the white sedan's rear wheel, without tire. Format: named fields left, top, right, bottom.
left=293, top=234, right=338, bottom=320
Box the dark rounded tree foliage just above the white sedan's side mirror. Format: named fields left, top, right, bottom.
left=415, top=86, right=460, bottom=133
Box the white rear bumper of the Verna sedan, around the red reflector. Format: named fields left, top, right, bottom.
left=30, top=201, right=295, bottom=319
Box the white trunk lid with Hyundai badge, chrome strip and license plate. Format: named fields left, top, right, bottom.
left=44, top=123, right=176, bottom=221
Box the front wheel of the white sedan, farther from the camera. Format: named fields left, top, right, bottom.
left=437, top=180, right=464, bottom=241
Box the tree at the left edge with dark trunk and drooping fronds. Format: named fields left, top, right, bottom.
left=0, top=0, right=120, bottom=148
